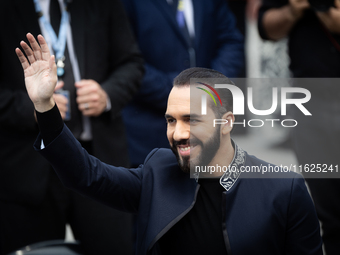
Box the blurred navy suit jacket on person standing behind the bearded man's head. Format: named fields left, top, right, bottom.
left=122, top=0, right=244, bottom=165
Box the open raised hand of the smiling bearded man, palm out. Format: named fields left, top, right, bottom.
left=15, top=33, right=58, bottom=112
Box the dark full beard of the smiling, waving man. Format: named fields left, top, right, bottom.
left=171, top=125, right=220, bottom=173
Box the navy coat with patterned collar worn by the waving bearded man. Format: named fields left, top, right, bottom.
left=35, top=126, right=322, bottom=255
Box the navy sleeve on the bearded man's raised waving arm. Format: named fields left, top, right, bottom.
left=34, top=125, right=142, bottom=213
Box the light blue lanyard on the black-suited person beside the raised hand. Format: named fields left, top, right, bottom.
left=34, top=0, right=69, bottom=76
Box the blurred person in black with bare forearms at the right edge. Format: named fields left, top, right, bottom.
left=258, top=0, right=340, bottom=255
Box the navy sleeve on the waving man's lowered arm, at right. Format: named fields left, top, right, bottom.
left=285, top=177, right=323, bottom=255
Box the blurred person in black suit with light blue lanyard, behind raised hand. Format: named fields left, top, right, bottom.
left=0, top=0, right=143, bottom=255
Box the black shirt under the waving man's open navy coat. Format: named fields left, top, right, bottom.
left=159, top=179, right=227, bottom=255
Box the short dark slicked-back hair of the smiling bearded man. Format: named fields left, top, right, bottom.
left=173, top=67, right=234, bottom=118
